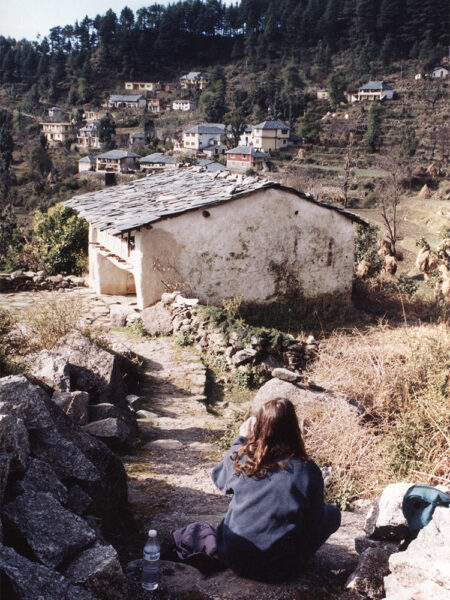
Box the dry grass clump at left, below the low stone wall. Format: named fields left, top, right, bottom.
left=21, top=293, right=83, bottom=350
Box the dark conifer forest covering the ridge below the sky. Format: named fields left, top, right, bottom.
left=0, top=0, right=448, bottom=104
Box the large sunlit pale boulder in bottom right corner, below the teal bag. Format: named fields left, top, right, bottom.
left=384, top=507, right=450, bottom=597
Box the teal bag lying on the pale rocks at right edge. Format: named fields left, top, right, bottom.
left=402, top=483, right=450, bottom=537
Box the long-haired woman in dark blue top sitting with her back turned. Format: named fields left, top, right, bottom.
left=212, top=398, right=341, bottom=581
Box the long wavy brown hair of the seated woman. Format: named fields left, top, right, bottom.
left=231, top=398, right=309, bottom=479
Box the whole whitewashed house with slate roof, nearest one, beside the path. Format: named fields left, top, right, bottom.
left=65, top=169, right=362, bottom=308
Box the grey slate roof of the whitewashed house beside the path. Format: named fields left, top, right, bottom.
left=64, top=169, right=364, bottom=235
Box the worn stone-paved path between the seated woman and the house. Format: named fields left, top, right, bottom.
left=112, top=332, right=229, bottom=544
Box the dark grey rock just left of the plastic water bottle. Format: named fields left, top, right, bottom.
left=63, top=543, right=127, bottom=600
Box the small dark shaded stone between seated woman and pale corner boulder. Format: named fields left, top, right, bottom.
left=346, top=546, right=392, bottom=600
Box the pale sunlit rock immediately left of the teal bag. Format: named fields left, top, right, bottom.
left=364, top=482, right=411, bottom=540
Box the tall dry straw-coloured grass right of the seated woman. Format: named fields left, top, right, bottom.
left=310, top=324, right=450, bottom=485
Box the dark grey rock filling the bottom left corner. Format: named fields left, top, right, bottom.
left=0, top=546, right=99, bottom=600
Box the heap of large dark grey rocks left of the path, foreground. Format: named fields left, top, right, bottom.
left=0, top=376, right=129, bottom=600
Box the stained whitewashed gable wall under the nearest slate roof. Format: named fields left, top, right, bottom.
left=135, top=189, right=353, bottom=307
